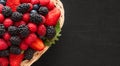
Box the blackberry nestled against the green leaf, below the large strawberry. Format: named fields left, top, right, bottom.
left=46, top=26, right=56, bottom=39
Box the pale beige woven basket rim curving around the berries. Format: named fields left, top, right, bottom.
left=20, top=0, right=64, bottom=66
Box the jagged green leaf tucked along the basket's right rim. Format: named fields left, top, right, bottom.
left=44, top=21, right=61, bottom=46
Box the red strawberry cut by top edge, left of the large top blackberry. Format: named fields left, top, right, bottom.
left=6, top=0, right=20, bottom=11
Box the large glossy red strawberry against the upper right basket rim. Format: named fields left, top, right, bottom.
left=45, top=8, right=61, bottom=26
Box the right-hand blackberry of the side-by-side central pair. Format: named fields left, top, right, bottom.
left=18, top=24, right=30, bottom=37
